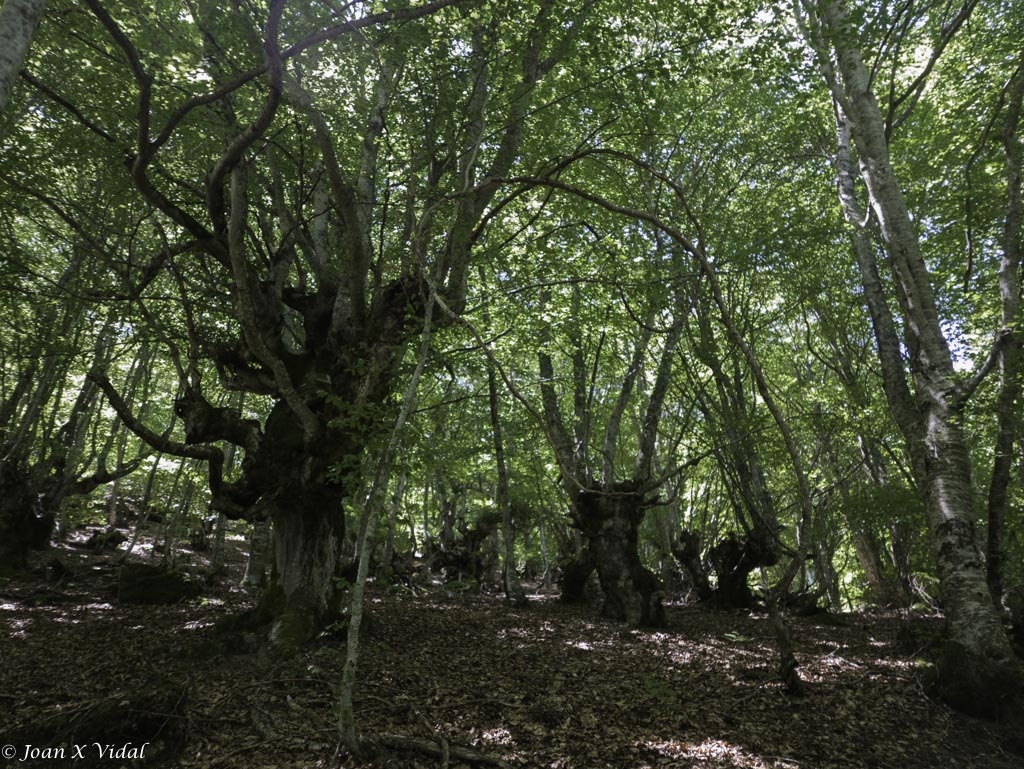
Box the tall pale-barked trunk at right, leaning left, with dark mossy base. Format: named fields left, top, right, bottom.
left=800, top=0, right=1024, bottom=715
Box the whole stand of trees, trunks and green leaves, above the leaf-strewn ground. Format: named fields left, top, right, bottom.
left=0, top=0, right=1024, bottom=737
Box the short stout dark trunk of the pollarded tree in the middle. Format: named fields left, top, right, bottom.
left=577, top=484, right=665, bottom=628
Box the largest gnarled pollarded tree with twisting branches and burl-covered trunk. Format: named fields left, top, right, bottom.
left=8, top=0, right=589, bottom=647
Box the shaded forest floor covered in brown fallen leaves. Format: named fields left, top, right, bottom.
left=0, top=528, right=1024, bottom=769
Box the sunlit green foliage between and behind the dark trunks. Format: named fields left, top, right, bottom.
left=0, top=0, right=1024, bottom=606
